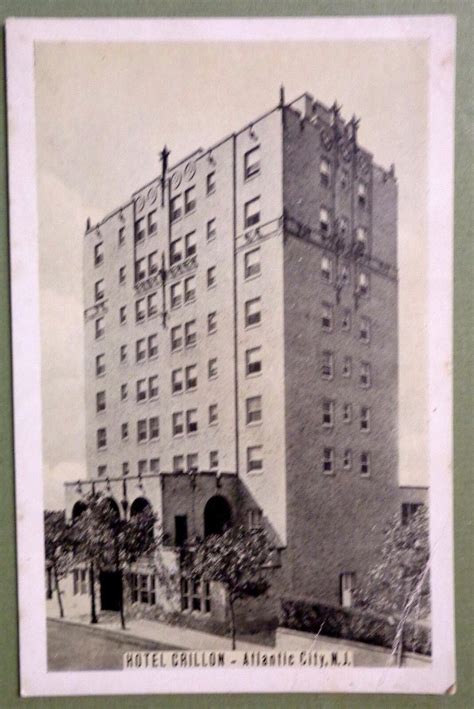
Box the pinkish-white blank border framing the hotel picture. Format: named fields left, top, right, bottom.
left=7, top=16, right=455, bottom=696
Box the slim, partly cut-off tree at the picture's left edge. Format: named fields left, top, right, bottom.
left=44, top=510, right=71, bottom=618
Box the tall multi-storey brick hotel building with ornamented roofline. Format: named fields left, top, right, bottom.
left=66, top=90, right=400, bottom=615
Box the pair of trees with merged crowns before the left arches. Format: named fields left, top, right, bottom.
left=72, top=493, right=156, bottom=629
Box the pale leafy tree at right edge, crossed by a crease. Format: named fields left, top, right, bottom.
left=355, top=506, right=430, bottom=664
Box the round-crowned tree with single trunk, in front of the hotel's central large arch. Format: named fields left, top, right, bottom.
left=187, top=526, right=270, bottom=650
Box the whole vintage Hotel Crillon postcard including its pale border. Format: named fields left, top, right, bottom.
left=7, top=16, right=455, bottom=696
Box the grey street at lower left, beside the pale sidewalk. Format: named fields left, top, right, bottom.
left=47, top=620, right=172, bottom=672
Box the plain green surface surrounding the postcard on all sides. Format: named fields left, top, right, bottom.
left=0, top=0, right=474, bottom=709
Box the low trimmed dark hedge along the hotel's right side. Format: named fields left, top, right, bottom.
left=281, top=598, right=431, bottom=655
